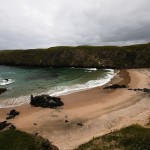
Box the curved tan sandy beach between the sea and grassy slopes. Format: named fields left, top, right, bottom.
left=0, top=69, right=150, bottom=150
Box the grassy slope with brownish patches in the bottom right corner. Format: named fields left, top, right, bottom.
left=76, top=125, right=150, bottom=150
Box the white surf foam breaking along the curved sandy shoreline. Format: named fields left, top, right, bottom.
left=0, top=68, right=117, bottom=108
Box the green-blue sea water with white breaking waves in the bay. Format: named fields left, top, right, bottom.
left=0, top=66, right=115, bottom=107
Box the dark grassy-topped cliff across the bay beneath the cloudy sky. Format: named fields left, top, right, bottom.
left=0, top=43, right=150, bottom=69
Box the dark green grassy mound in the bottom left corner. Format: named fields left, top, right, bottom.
left=0, top=130, right=57, bottom=150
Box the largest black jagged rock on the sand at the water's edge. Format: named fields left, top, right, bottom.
left=30, top=94, right=64, bottom=108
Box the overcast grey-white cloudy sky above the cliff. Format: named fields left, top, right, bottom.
left=0, top=0, right=150, bottom=49
